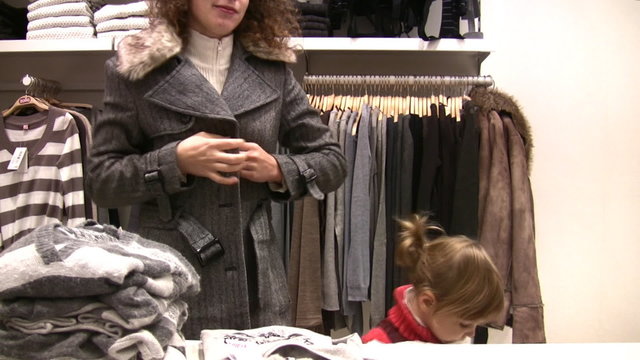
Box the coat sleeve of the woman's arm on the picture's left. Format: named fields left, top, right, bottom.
left=87, top=58, right=186, bottom=207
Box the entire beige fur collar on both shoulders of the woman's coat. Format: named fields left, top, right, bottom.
left=118, top=20, right=296, bottom=80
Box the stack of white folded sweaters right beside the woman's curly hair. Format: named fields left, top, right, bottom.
left=93, top=1, right=149, bottom=42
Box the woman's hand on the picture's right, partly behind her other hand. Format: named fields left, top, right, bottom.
left=238, top=142, right=282, bottom=184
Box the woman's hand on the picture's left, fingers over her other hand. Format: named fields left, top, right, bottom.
left=176, top=132, right=247, bottom=185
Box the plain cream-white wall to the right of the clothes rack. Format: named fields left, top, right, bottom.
left=482, top=0, right=640, bottom=343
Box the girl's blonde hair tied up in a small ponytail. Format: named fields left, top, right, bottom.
left=396, top=215, right=504, bottom=321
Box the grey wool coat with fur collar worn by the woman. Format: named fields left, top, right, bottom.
left=88, top=22, right=346, bottom=339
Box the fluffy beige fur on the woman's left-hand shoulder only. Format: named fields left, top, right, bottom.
left=118, top=21, right=182, bottom=80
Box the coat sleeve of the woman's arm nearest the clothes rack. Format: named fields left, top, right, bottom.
left=273, top=69, right=346, bottom=200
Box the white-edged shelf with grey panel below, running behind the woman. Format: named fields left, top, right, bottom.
left=0, top=37, right=490, bottom=104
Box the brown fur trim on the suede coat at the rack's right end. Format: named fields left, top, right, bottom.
left=469, top=86, right=533, bottom=169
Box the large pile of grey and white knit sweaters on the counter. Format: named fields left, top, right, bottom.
left=0, top=221, right=200, bottom=359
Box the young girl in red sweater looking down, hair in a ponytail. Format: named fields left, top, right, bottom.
left=362, top=215, right=504, bottom=343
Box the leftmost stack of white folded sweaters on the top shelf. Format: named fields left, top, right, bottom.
left=27, top=0, right=104, bottom=39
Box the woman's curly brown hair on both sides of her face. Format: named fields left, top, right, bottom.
left=150, top=0, right=300, bottom=50
